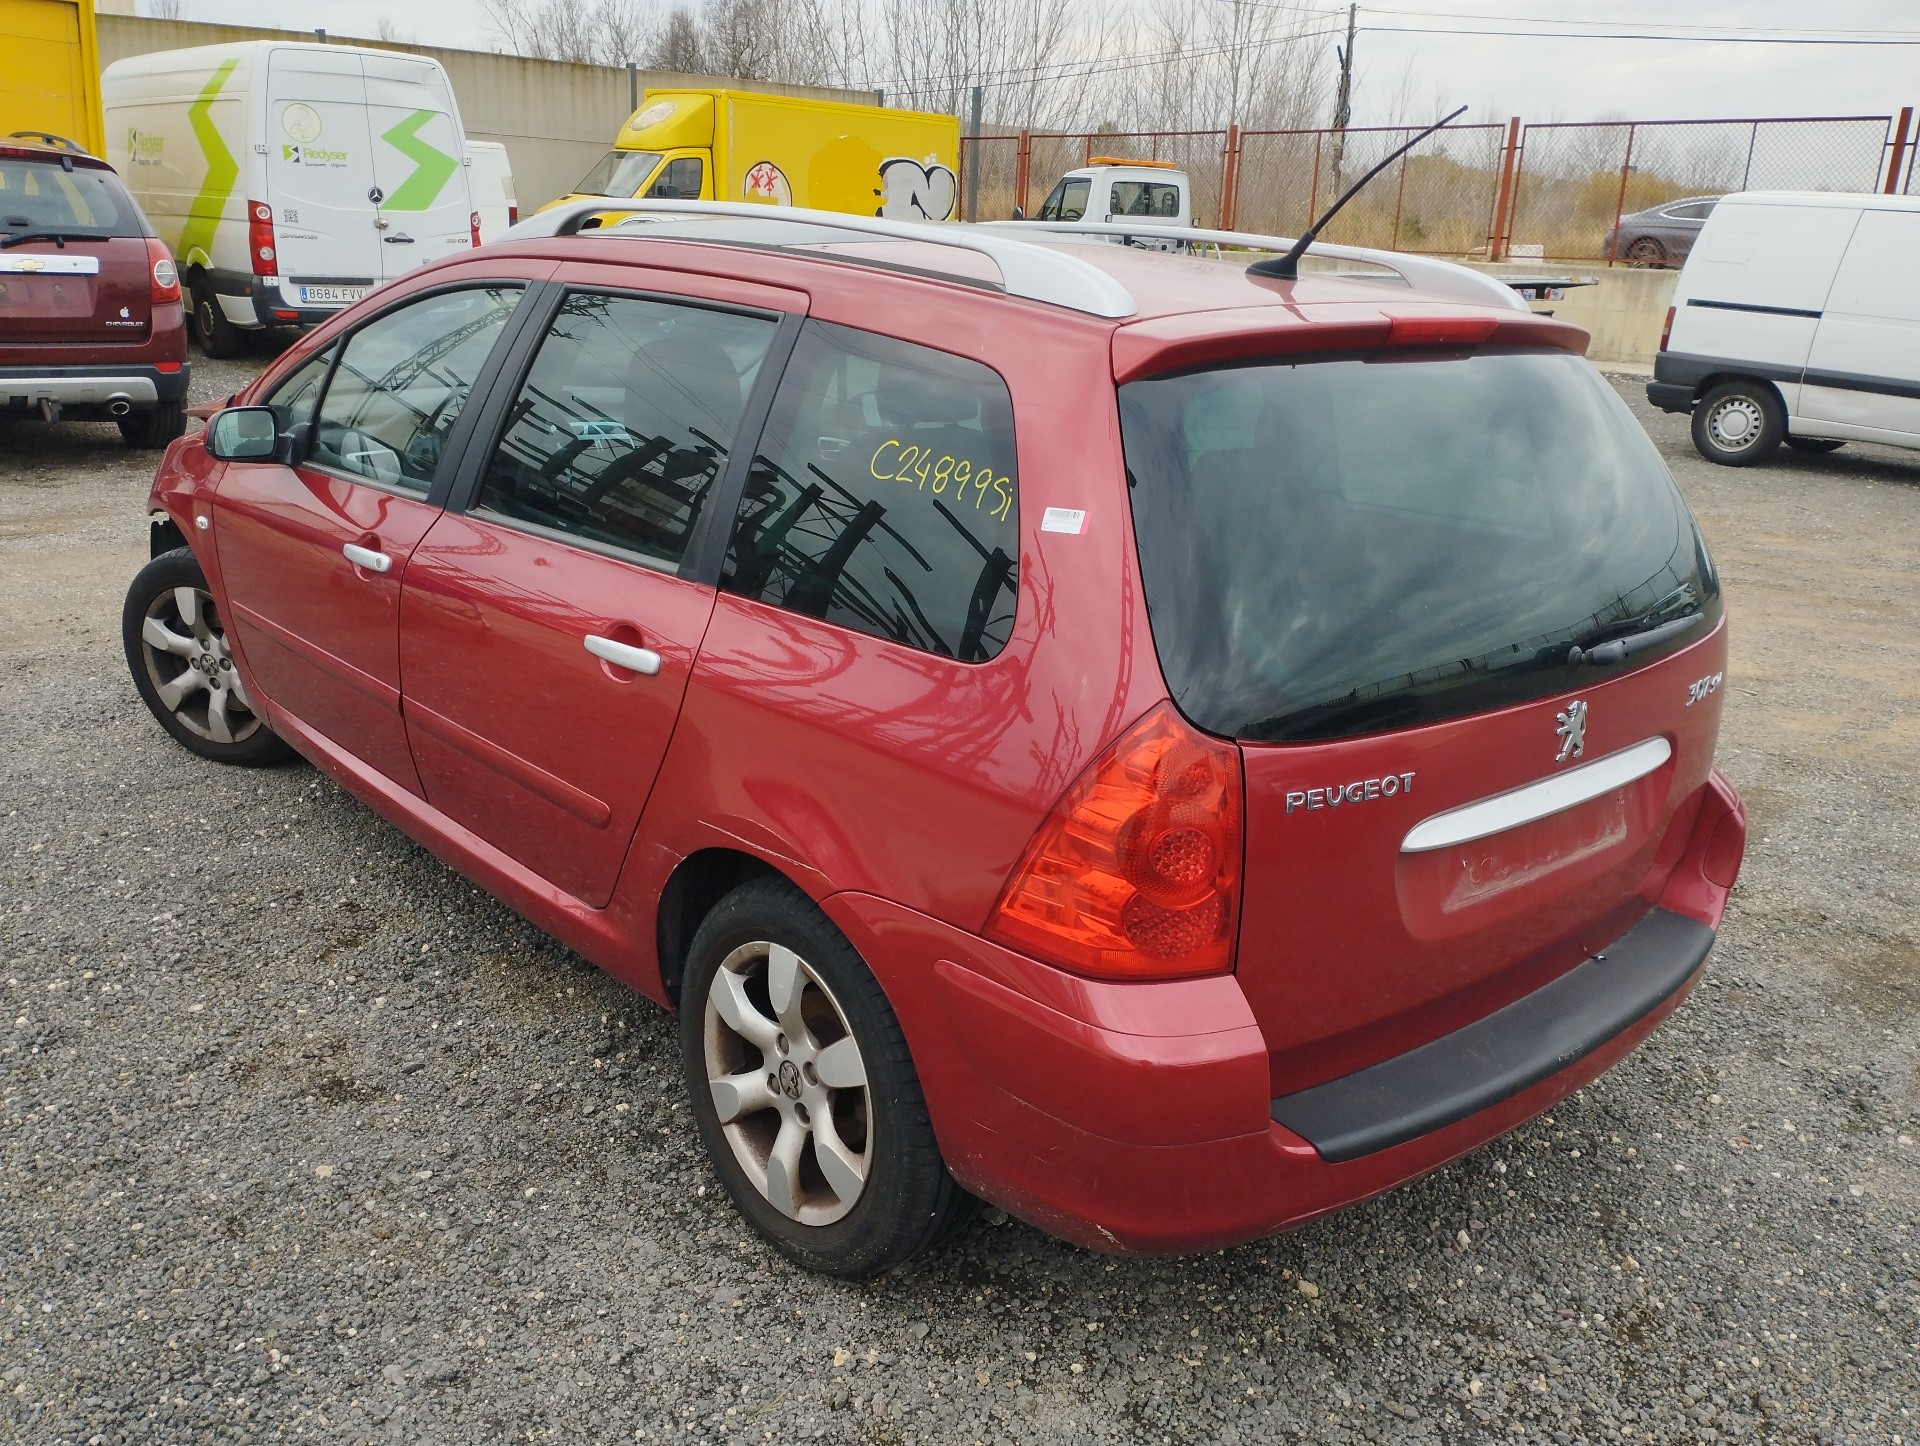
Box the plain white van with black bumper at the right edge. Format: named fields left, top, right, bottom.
left=1647, top=190, right=1920, bottom=467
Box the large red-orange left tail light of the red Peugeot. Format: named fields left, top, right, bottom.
left=987, top=703, right=1242, bottom=979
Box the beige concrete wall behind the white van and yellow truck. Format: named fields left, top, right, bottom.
left=100, top=10, right=874, bottom=215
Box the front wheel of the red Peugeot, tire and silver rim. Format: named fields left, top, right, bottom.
left=121, top=547, right=294, bottom=768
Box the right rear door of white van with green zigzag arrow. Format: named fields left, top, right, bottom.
left=365, top=56, right=474, bottom=278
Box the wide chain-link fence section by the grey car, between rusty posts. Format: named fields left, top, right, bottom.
left=1505, top=115, right=1895, bottom=263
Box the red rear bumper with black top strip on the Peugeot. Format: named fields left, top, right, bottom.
left=824, top=776, right=1745, bottom=1254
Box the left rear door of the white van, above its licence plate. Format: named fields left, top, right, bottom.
left=264, top=46, right=382, bottom=307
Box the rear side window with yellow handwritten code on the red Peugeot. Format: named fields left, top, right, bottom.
left=722, top=321, right=1020, bottom=663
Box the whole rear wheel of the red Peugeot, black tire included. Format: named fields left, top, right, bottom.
left=680, top=878, right=973, bottom=1277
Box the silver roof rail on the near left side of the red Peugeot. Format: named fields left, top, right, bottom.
left=499, top=198, right=1139, bottom=317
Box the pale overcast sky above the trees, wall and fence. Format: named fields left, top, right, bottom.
left=142, top=0, right=1920, bottom=125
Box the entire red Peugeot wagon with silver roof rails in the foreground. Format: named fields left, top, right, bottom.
left=125, top=204, right=1745, bottom=1275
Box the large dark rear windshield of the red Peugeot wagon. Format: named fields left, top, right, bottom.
left=1119, top=351, right=1720, bottom=741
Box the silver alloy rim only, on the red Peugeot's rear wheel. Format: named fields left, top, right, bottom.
left=703, top=939, right=874, bottom=1225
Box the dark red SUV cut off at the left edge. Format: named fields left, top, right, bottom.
left=0, top=133, right=188, bottom=447
